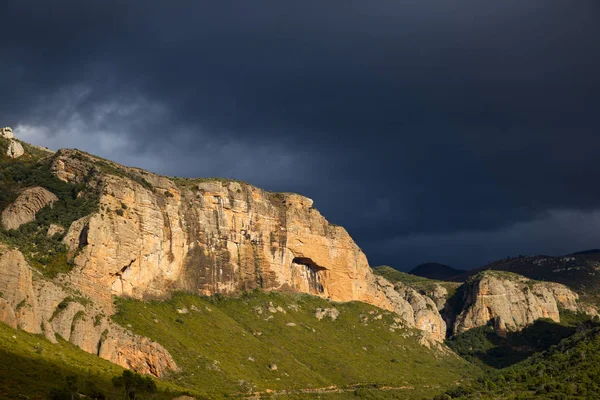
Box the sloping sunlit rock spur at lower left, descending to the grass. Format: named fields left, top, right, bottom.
left=0, top=245, right=177, bottom=376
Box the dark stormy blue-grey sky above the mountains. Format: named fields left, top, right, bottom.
left=0, top=0, right=600, bottom=269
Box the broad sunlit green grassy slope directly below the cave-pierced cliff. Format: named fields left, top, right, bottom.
left=114, top=292, right=477, bottom=398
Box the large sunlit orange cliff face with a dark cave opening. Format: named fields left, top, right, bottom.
left=45, top=150, right=444, bottom=340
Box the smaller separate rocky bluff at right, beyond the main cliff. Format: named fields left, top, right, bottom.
left=453, top=271, right=578, bottom=335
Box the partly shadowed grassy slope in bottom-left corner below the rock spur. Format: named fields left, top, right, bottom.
left=0, top=323, right=195, bottom=400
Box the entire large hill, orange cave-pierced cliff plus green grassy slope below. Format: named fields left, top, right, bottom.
left=0, top=130, right=478, bottom=398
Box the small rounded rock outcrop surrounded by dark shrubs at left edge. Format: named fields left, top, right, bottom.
left=2, top=187, right=58, bottom=230
